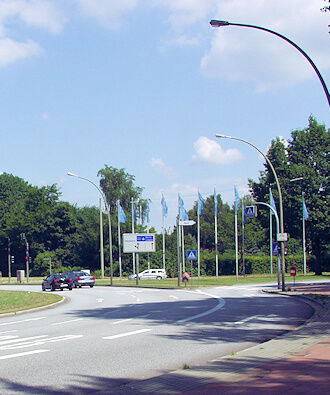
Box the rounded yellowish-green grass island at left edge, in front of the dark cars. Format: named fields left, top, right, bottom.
left=0, top=291, right=62, bottom=314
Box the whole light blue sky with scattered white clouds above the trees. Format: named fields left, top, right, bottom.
left=0, top=0, right=330, bottom=231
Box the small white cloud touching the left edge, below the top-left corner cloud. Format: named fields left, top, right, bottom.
left=0, top=38, right=42, bottom=67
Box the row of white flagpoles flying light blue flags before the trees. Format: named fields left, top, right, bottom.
left=117, top=185, right=309, bottom=280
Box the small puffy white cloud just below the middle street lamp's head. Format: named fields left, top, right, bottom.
left=193, top=136, right=243, bottom=165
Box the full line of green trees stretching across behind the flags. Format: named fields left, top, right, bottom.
left=0, top=117, right=330, bottom=276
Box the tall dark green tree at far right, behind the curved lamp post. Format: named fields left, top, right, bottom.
left=250, top=117, right=330, bottom=274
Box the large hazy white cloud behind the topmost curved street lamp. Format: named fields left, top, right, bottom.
left=201, top=0, right=330, bottom=91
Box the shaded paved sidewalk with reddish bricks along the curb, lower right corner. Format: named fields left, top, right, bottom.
left=98, top=283, right=330, bottom=395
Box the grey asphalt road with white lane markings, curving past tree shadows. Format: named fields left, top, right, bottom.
left=0, top=285, right=313, bottom=394
